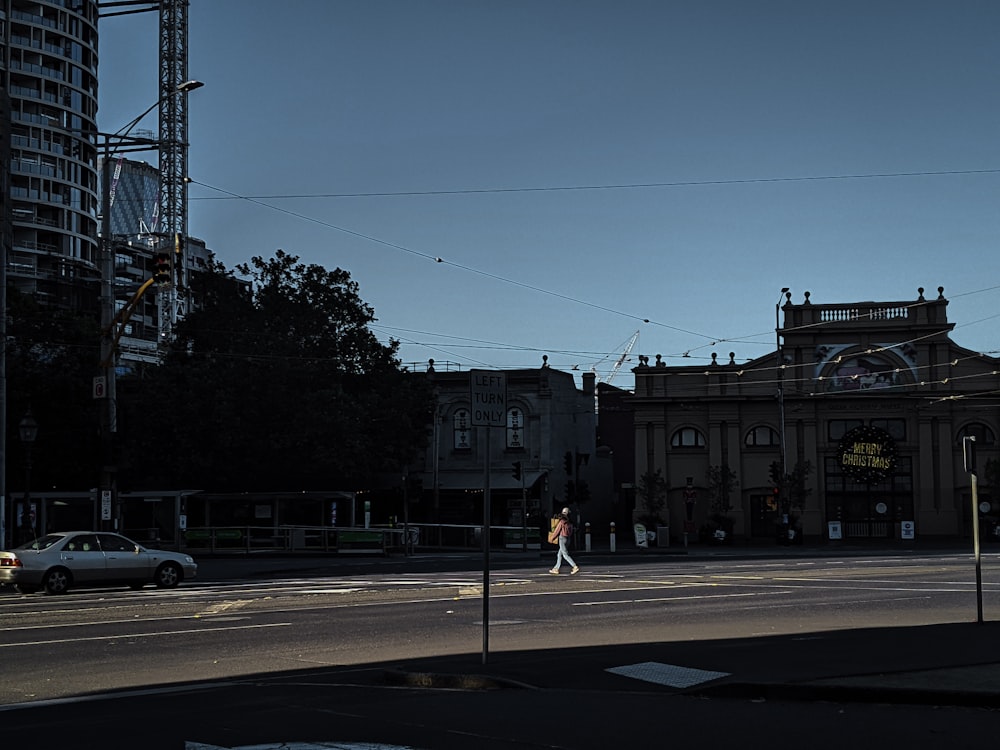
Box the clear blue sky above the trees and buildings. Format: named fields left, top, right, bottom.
left=98, top=0, right=1000, bottom=388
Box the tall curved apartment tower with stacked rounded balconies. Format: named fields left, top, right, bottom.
left=0, top=0, right=100, bottom=310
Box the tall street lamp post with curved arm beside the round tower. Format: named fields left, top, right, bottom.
left=95, top=81, right=205, bottom=523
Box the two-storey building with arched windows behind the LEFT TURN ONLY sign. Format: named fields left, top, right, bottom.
left=411, top=365, right=613, bottom=539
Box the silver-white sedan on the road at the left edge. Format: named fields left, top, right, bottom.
left=0, top=531, right=198, bottom=594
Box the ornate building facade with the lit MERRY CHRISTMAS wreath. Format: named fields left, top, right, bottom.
left=629, top=288, right=1000, bottom=541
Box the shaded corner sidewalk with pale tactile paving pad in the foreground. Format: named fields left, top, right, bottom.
left=386, top=622, right=1000, bottom=708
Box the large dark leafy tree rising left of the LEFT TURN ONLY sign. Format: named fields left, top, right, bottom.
left=117, top=250, right=432, bottom=491
